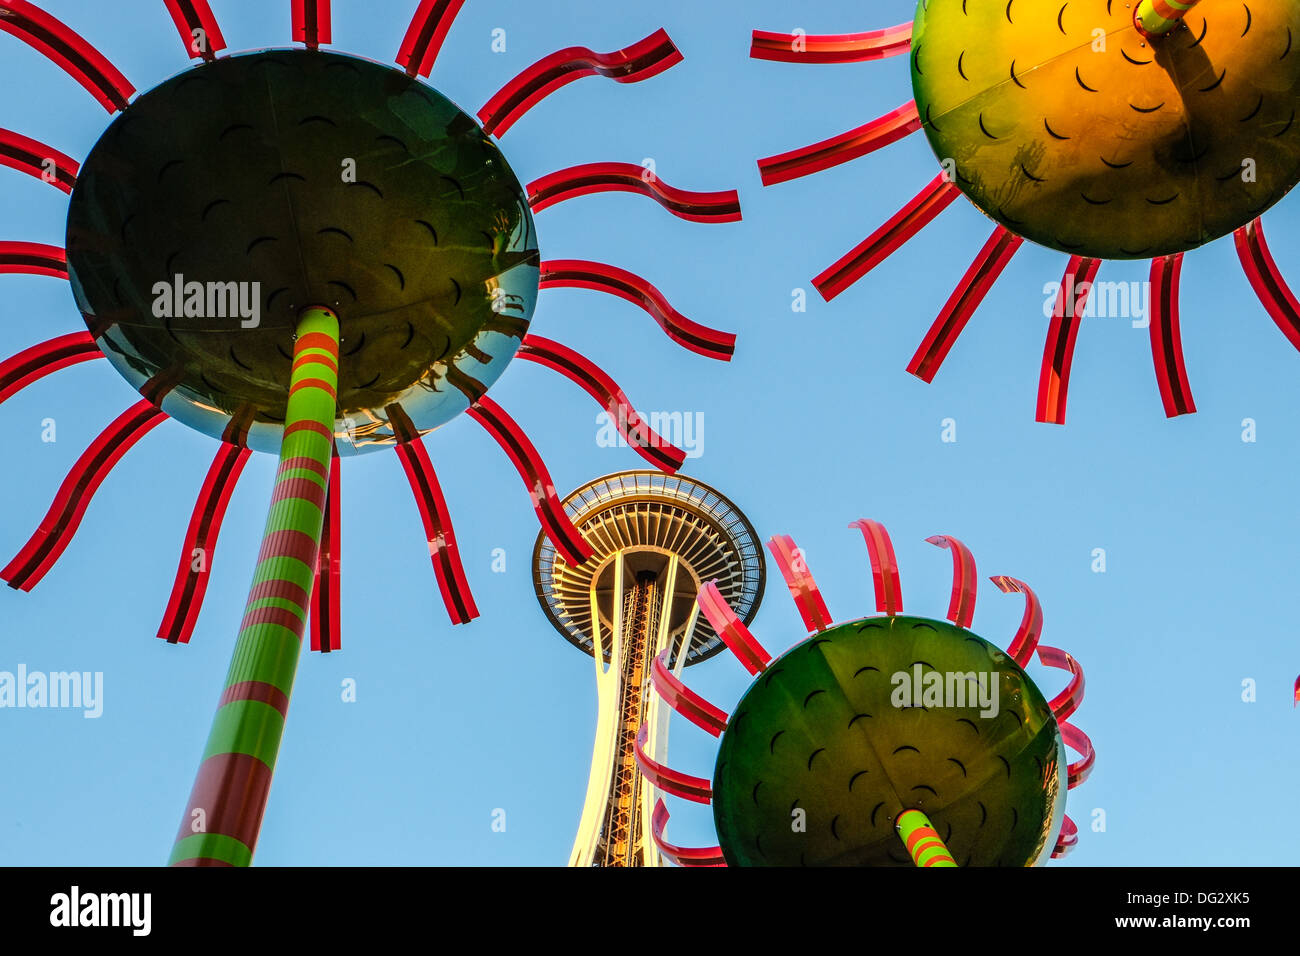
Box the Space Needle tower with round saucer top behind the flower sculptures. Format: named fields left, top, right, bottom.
left=533, top=472, right=764, bottom=866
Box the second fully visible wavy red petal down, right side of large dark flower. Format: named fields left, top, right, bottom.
left=528, top=163, right=741, bottom=222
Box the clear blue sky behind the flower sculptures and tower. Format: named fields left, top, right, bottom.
left=0, top=0, right=1300, bottom=865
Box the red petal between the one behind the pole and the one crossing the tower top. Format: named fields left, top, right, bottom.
left=386, top=405, right=478, bottom=624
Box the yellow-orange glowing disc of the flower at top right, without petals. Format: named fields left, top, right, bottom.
left=911, top=0, right=1300, bottom=259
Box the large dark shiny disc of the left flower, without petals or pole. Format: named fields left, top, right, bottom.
left=68, top=49, right=538, bottom=455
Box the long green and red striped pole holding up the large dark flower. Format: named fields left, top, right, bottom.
left=170, top=308, right=338, bottom=866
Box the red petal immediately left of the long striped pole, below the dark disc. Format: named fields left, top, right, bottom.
left=159, top=442, right=252, bottom=644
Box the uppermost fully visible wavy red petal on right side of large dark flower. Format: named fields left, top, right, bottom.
left=478, top=30, right=683, bottom=137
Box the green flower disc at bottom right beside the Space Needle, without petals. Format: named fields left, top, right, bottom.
left=714, top=615, right=1066, bottom=866
